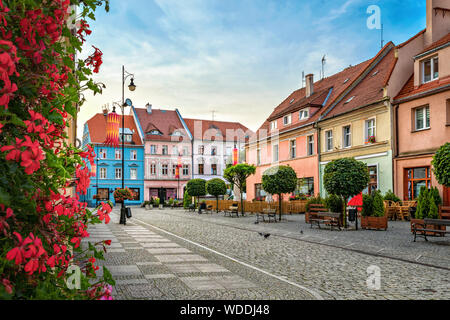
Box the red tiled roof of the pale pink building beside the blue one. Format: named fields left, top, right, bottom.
left=134, top=108, right=187, bottom=141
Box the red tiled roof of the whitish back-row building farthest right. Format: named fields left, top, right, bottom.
left=184, top=118, right=253, bottom=141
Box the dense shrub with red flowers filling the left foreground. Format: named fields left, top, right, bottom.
left=0, top=0, right=114, bottom=300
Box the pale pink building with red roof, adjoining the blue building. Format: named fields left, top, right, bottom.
left=132, top=104, right=192, bottom=203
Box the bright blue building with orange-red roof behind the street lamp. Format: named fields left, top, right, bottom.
left=81, top=114, right=144, bottom=207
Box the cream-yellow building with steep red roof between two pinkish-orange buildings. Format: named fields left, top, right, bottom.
left=317, top=42, right=395, bottom=195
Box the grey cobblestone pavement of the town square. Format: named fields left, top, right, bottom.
left=89, top=208, right=450, bottom=300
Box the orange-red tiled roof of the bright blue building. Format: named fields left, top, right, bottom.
left=87, top=113, right=142, bottom=146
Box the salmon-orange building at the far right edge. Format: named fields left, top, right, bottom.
left=394, top=32, right=450, bottom=204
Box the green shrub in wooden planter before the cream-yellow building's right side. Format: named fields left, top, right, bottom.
left=361, top=191, right=388, bottom=231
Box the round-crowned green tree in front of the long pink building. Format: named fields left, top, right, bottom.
left=262, top=166, right=298, bottom=221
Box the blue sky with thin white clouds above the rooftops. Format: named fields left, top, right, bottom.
left=78, top=0, right=426, bottom=136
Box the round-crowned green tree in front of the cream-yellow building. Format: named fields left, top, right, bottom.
left=323, top=158, right=369, bottom=226
